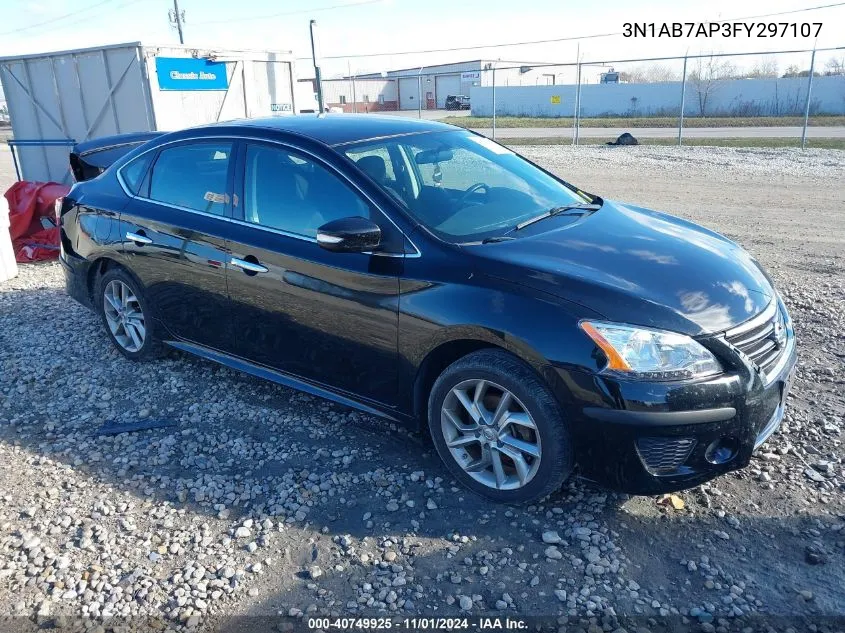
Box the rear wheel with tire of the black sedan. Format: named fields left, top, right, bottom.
left=94, top=268, right=164, bottom=361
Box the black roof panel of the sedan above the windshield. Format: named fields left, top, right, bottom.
left=220, top=114, right=460, bottom=146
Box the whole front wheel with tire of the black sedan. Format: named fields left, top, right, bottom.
left=428, top=350, right=574, bottom=504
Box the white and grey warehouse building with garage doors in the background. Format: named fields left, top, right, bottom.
left=346, top=59, right=554, bottom=110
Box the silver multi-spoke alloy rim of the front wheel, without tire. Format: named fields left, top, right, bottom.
left=440, top=379, right=542, bottom=490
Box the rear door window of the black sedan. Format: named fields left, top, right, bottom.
left=149, top=141, right=232, bottom=216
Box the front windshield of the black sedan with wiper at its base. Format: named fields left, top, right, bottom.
left=342, top=130, right=593, bottom=243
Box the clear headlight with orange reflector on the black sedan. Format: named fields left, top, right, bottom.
left=580, top=321, right=722, bottom=380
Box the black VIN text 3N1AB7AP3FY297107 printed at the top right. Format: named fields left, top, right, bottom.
left=622, top=22, right=822, bottom=38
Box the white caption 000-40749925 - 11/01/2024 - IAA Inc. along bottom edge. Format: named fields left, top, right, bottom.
left=307, top=617, right=529, bottom=631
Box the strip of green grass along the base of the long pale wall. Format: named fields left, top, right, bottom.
left=442, top=116, right=845, bottom=128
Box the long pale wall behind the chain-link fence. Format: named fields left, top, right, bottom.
left=470, top=72, right=845, bottom=117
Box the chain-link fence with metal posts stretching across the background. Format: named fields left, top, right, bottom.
left=314, top=46, right=845, bottom=148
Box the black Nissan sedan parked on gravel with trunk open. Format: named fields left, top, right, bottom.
left=60, top=115, right=796, bottom=502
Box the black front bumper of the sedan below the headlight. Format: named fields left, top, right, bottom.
left=570, top=312, right=797, bottom=494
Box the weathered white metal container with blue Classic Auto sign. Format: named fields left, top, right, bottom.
left=0, top=42, right=296, bottom=183
